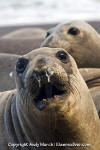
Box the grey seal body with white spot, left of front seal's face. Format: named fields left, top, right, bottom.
left=0, top=53, right=19, bottom=92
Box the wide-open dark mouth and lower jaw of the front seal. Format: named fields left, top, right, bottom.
left=34, top=82, right=67, bottom=110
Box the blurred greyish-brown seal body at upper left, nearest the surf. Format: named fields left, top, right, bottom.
left=0, top=27, right=46, bottom=55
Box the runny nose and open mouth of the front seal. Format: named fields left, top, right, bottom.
left=30, top=67, right=65, bottom=110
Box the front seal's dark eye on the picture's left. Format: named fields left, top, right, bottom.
left=16, top=58, right=28, bottom=73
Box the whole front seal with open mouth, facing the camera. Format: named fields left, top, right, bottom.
left=0, top=48, right=100, bottom=150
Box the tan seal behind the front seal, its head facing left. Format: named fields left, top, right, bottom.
left=41, top=21, right=100, bottom=68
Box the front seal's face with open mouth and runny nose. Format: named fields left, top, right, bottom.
left=16, top=48, right=74, bottom=110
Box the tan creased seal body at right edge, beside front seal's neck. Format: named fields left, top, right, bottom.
left=79, top=68, right=100, bottom=117
